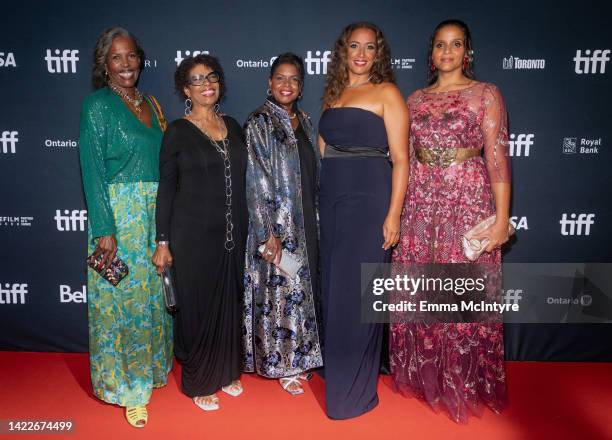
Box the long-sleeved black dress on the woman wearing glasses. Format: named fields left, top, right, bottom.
left=156, top=116, right=248, bottom=397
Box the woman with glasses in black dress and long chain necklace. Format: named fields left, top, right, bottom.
left=153, top=55, right=248, bottom=411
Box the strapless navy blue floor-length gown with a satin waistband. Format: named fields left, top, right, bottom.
left=319, top=107, right=391, bottom=419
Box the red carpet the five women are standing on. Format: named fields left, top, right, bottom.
left=0, top=352, right=612, bottom=440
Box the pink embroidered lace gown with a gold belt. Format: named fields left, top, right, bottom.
left=390, top=82, right=510, bottom=423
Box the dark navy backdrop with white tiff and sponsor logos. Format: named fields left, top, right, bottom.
left=0, top=0, right=612, bottom=360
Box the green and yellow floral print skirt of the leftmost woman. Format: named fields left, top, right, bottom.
left=87, top=182, right=173, bottom=406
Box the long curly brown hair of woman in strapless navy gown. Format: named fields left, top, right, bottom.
left=323, top=21, right=395, bottom=107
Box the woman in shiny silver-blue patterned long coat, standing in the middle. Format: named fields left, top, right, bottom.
left=243, top=53, right=322, bottom=395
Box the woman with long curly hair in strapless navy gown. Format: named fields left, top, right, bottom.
left=319, top=23, right=408, bottom=419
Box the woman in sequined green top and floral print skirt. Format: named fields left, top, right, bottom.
left=80, top=27, right=172, bottom=428
